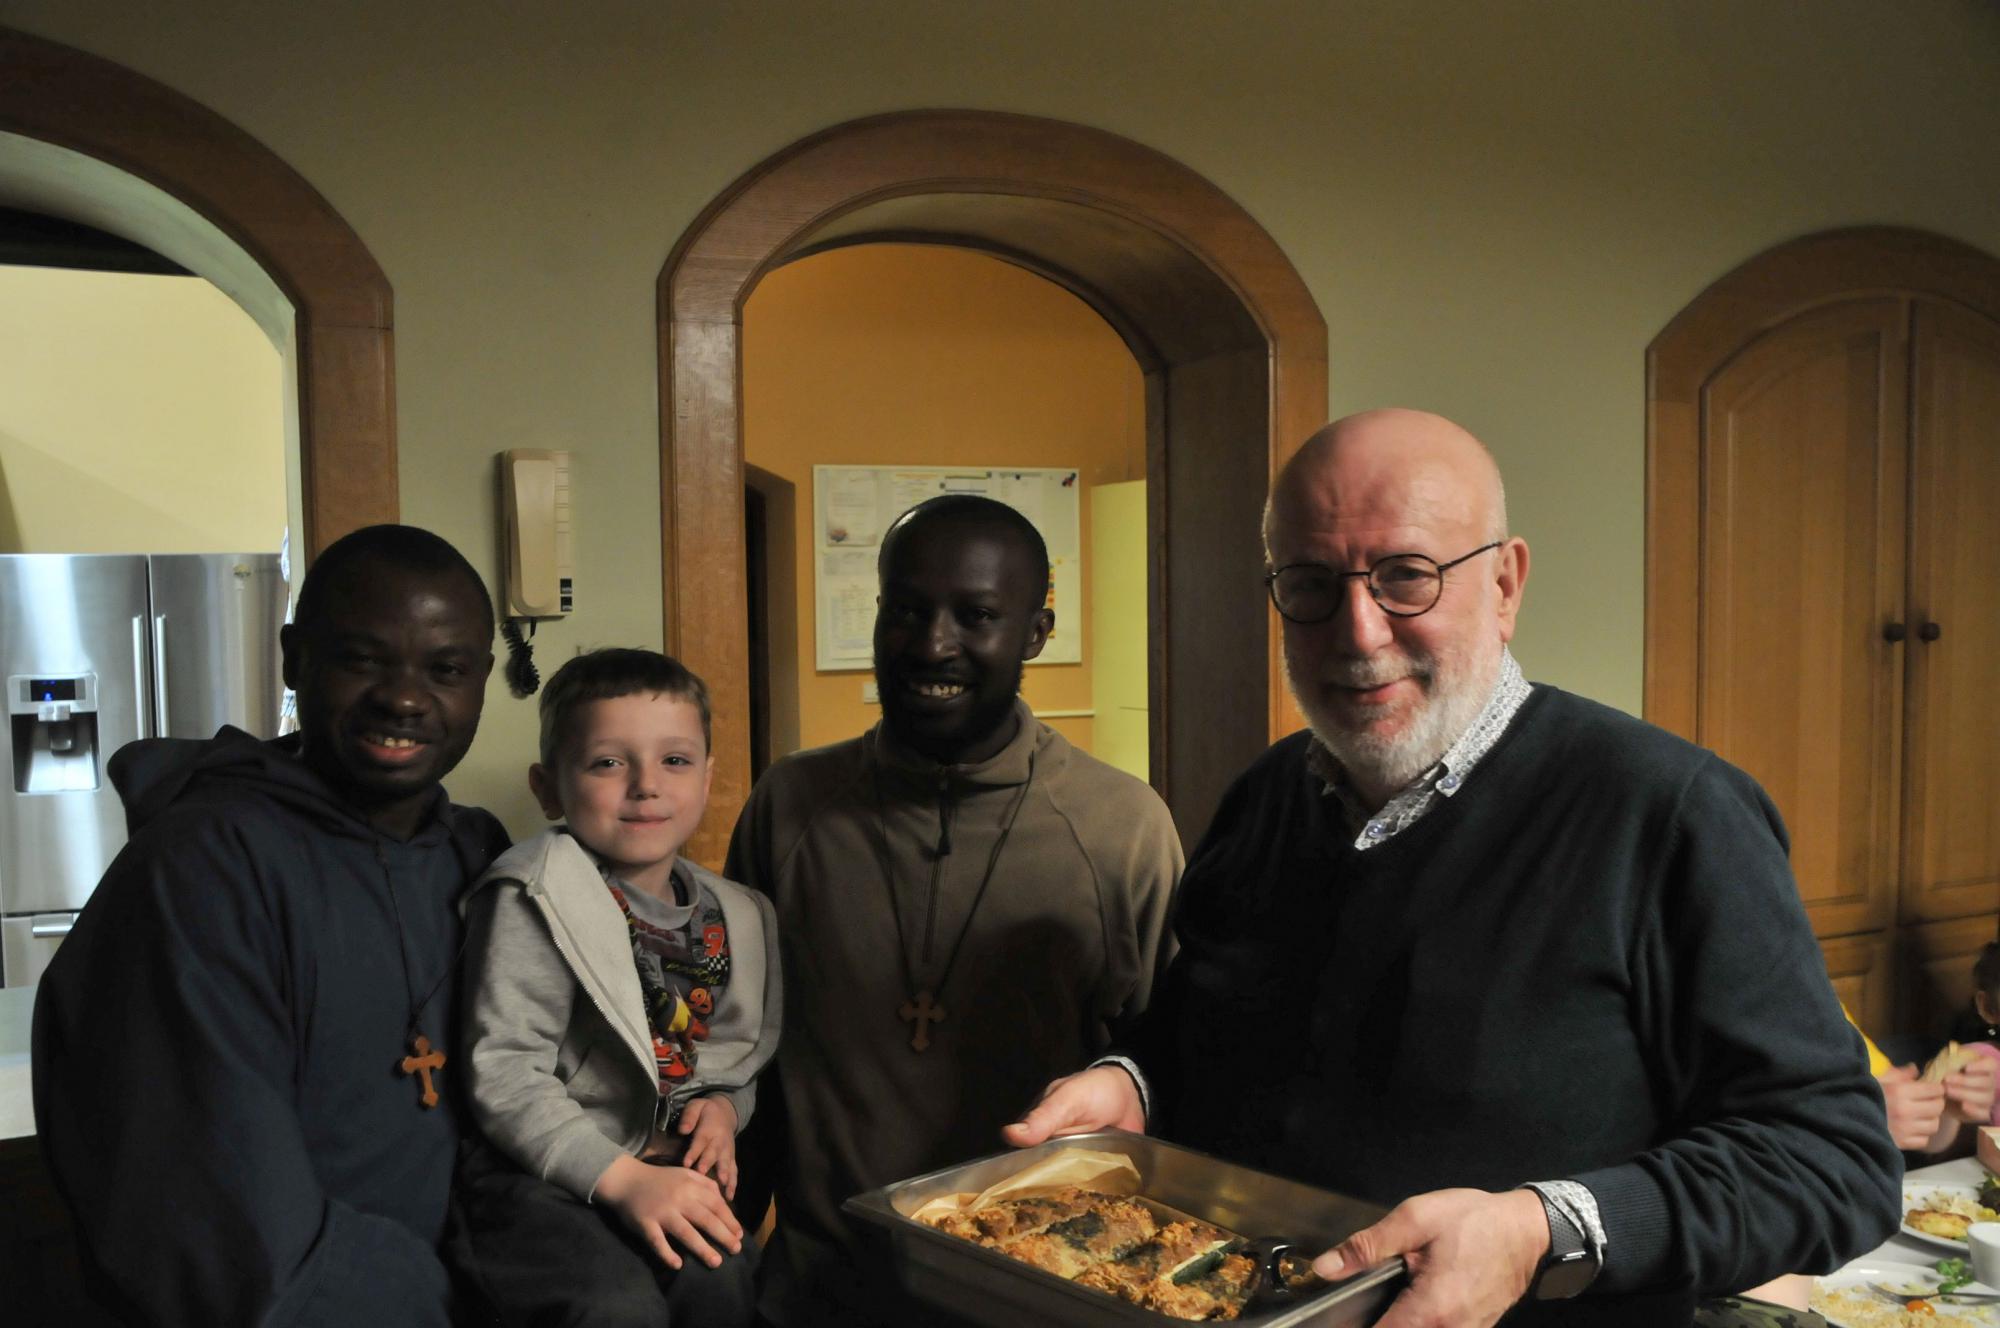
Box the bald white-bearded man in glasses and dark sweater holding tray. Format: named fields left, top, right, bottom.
left=1008, top=410, right=1902, bottom=1328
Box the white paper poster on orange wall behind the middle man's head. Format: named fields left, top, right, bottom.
left=812, top=466, right=1084, bottom=672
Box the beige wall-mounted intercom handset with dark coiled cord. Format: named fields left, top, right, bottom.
left=498, top=448, right=576, bottom=696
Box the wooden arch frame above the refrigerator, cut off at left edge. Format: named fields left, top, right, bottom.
left=0, top=28, right=398, bottom=554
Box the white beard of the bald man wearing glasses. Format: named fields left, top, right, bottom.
left=1284, top=644, right=1500, bottom=792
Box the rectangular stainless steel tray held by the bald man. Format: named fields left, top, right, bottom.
left=844, top=1130, right=1404, bottom=1328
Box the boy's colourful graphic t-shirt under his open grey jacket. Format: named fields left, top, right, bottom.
left=604, top=864, right=730, bottom=1124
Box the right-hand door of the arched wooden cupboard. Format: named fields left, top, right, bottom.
left=1902, top=300, right=2000, bottom=930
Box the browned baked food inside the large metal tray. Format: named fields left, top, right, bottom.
left=930, top=1186, right=1318, bottom=1320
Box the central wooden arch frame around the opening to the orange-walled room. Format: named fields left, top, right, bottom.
left=658, top=110, right=1326, bottom=862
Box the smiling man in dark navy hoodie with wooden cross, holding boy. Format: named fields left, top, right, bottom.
left=34, top=526, right=506, bottom=1326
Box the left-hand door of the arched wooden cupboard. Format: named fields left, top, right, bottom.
left=1696, top=298, right=1908, bottom=936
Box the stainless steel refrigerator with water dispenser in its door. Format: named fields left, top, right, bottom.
left=0, top=554, right=286, bottom=986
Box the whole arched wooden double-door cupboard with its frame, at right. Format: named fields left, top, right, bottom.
left=1646, top=228, right=2000, bottom=1036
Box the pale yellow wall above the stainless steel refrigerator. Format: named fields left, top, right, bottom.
left=0, top=266, right=286, bottom=554
